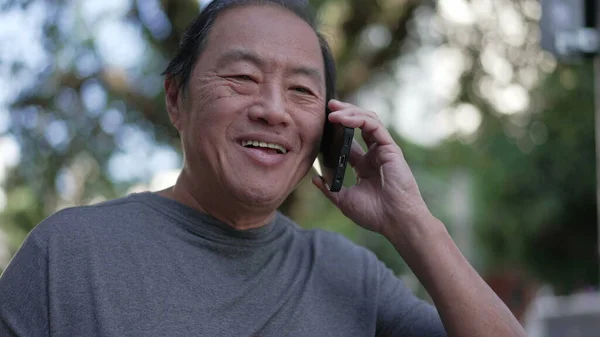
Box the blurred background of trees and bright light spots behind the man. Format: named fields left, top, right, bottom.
left=0, top=0, right=599, bottom=330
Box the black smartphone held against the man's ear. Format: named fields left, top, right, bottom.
left=318, top=111, right=354, bottom=192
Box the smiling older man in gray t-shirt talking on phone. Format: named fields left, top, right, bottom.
left=0, top=0, right=524, bottom=337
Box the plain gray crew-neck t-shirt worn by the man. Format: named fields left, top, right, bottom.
left=0, top=193, right=446, bottom=337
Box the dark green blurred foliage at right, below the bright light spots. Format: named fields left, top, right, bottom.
left=476, top=61, right=598, bottom=293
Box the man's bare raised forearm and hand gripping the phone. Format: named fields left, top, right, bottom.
left=313, top=100, right=525, bottom=337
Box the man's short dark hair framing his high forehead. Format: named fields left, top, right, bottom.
left=163, top=0, right=336, bottom=104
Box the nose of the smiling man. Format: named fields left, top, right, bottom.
left=249, top=83, right=291, bottom=125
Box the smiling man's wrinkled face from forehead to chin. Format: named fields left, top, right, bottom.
left=171, top=5, right=325, bottom=208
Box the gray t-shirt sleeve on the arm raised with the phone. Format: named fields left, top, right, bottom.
left=377, top=263, right=447, bottom=337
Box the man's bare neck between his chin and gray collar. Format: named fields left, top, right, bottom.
left=157, top=171, right=275, bottom=230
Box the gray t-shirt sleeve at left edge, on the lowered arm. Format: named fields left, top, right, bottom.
left=0, top=234, right=50, bottom=337
